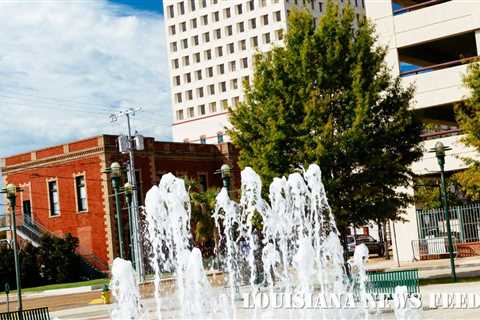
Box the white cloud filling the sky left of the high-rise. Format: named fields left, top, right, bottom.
left=0, top=0, right=171, bottom=157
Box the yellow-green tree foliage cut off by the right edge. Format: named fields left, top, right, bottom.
left=455, top=62, right=480, bottom=201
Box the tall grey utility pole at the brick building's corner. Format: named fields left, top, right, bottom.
left=110, top=107, right=145, bottom=282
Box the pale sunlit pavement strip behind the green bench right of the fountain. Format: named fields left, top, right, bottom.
left=367, top=256, right=480, bottom=279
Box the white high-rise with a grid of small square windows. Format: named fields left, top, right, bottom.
left=164, top=0, right=364, bottom=143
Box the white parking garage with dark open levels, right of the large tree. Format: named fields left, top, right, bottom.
left=365, top=0, right=480, bottom=261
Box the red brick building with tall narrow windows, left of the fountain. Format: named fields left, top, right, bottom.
left=0, top=135, right=239, bottom=270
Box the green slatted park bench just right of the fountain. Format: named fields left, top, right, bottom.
left=366, top=269, right=420, bottom=297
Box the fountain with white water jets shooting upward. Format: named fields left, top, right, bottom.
left=112, top=164, right=408, bottom=319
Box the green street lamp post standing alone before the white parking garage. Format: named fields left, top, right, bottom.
left=431, top=141, right=457, bottom=282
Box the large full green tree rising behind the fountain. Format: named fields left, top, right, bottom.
left=229, top=2, right=422, bottom=231
